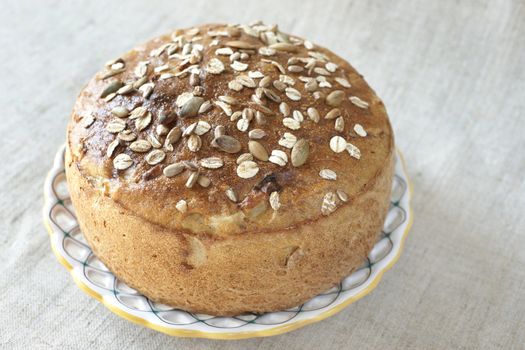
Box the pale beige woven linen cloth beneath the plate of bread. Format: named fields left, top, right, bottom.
left=0, top=0, right=525, bottom=350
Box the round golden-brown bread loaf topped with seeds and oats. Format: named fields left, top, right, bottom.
left=66, top=22, right=394, bottom=315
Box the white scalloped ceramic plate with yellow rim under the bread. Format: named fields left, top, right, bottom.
left=43, top=146, right=412, bottom=339
